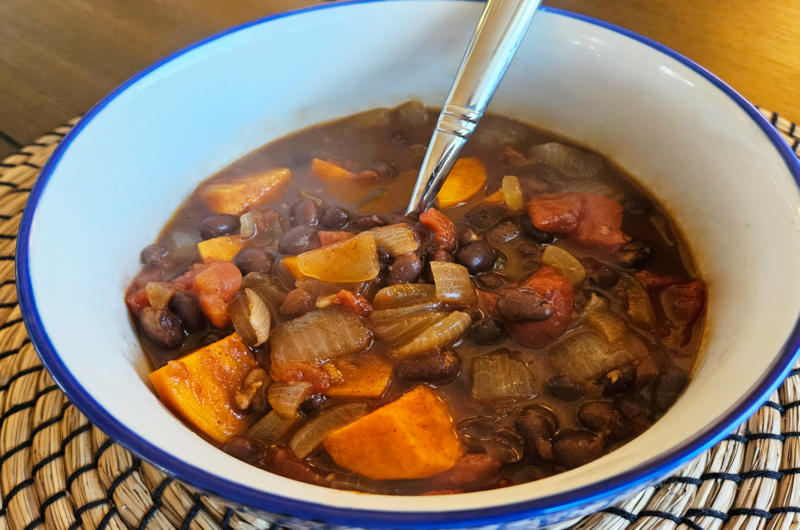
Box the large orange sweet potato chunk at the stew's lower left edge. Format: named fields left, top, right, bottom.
left=150, top=333, right=257, bottom=443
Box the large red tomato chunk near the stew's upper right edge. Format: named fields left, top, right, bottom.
left=528, top=193, right=626, bottom=249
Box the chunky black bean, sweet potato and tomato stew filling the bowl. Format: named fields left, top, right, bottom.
left=125, top=102, right=706, bottom=495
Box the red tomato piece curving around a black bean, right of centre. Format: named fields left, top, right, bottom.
left=506, top=267, right=575, bottom=348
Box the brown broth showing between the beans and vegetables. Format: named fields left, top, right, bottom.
left=128, top=102, right=705, bottom=494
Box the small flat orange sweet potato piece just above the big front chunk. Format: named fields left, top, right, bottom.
left=323, top=355, right=392, bottom=399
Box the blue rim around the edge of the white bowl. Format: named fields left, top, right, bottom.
left=16, top=0, right=800, bottom=528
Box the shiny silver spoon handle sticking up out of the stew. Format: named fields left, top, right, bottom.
left=406, top=0, right=542, bottom=215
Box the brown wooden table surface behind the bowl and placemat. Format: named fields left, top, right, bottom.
left=0, top=0, right=800, bottom=158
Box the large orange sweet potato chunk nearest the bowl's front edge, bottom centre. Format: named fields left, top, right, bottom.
left=324, top=385, right=463, bottom=480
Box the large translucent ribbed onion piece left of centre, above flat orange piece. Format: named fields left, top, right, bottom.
left=270, top=307, right=372, bottom=372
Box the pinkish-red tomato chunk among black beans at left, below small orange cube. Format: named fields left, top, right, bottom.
left=194, top=261, right=242, bottom=328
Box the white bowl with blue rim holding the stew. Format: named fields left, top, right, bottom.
left=17, top=0, right=800, bottom=528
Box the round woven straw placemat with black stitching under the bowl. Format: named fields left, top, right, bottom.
left=0, top=109, right=800, bottom=530
